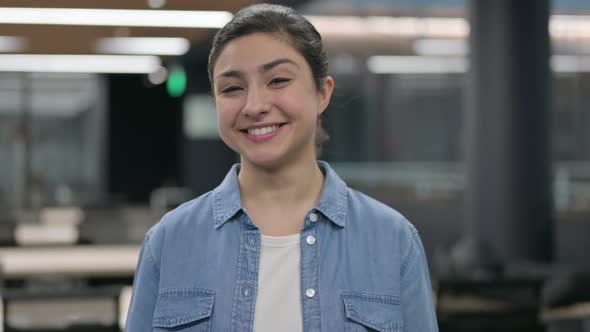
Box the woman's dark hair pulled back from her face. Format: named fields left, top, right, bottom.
left=207, top=4, right=329, bottom=155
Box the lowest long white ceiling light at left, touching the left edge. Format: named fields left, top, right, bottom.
left=0, top=54, right=160, bottom=74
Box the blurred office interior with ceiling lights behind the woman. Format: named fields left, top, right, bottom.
left=0, top=0, right=590, bottom=332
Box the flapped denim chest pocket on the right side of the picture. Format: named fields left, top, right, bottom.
left=341, top=292, right=404, bottom=332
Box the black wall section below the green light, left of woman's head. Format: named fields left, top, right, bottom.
left=107, top=75, right=182, bottom=203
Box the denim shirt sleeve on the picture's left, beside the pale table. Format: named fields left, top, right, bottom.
left=125, top=235, right=159, bottom=332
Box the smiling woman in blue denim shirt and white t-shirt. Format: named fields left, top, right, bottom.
left=127, top=5, right=437, bottom=332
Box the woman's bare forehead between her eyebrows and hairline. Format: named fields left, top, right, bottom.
left=213, top=33, right=306, bottom=76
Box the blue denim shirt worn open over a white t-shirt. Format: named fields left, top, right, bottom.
left=125, top=161, right=438, bottom=332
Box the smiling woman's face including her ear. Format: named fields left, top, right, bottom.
left=213, top=33, right=334, bottom=168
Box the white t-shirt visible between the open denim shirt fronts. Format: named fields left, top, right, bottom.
left=254, top=234, right=303, bottom=332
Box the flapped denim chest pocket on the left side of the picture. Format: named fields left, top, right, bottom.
left=152, top=288, right=215, bottom=332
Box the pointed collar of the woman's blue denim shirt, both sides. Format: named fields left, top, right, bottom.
left=212, top=161, right=347, bottom=228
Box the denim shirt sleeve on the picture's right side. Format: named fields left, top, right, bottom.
left=401, top=223, right=438, bottom=332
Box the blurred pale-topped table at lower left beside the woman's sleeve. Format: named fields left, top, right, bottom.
left=0, top=245, right=140, bottom=332
